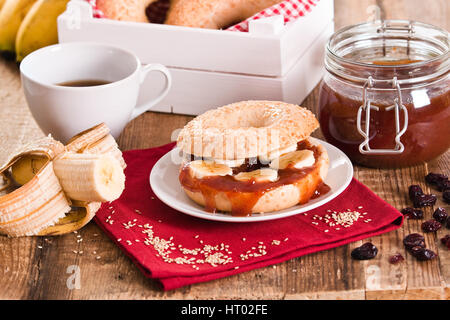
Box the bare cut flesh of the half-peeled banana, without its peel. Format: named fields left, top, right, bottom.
left=53, top=153, right=125, bottom=202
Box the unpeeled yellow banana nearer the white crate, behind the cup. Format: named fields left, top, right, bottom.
left=14, top=0, right=69, bottom=62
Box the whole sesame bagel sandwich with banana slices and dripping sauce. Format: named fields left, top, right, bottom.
left=177, top=101, right=329, bottom=216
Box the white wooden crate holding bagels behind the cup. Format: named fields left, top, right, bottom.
left=58, top=0, right=333, bottom=115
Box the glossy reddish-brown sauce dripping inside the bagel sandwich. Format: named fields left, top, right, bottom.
left=179, top=141, right=330, bottom=216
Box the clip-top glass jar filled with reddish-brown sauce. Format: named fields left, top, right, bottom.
left=319, top=20, right=450, bottom=168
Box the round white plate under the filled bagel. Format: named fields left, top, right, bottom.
left=150, top=138, right=353, bottom=222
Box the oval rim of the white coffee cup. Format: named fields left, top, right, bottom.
left=19, top=41, right=141, bottom=91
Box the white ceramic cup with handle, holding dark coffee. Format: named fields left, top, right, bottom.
left=20, top=42, right=171, bottom=143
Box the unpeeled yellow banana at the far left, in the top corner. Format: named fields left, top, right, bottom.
left=0, top=0, right=36, bottom=52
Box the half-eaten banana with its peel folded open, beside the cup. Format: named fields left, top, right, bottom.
left=0, top=124, right=125, bottom=237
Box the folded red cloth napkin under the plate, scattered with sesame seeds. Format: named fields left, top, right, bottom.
left=95, top=143, right=403, bottom=290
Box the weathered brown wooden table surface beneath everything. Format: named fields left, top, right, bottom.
left=0, top=0, right=450, bottom=299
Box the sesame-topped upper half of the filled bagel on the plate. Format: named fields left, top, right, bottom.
left=177, top=101, right=319, bottom=160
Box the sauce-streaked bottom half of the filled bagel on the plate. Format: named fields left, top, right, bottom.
left=182, top=142, right=329, bottom=216
